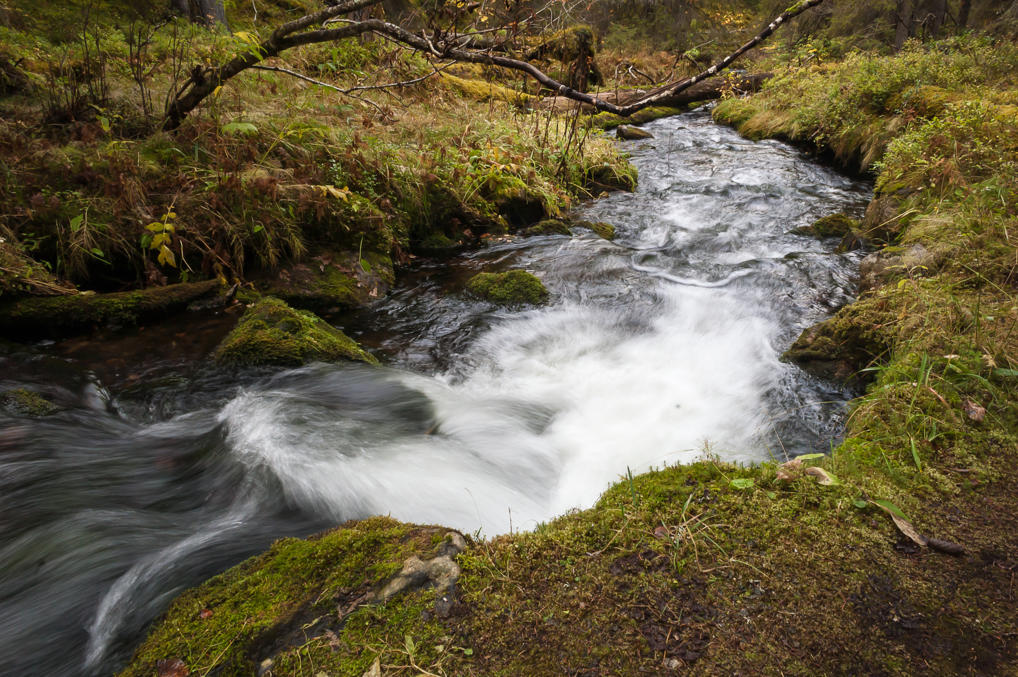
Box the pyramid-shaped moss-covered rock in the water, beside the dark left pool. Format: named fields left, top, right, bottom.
left=215, top=296, right=378, bottom=366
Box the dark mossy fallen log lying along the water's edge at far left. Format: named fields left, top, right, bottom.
left=0, top=280, right=220, bottom=340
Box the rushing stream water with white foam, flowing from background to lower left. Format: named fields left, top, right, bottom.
left=0, top=112, right=868, bottom=675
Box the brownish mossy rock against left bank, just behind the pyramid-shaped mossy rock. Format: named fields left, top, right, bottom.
left=258, top=251, right=395, bottom=313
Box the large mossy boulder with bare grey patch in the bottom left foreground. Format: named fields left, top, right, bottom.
left=120, top=517, right=465, bottom=677
